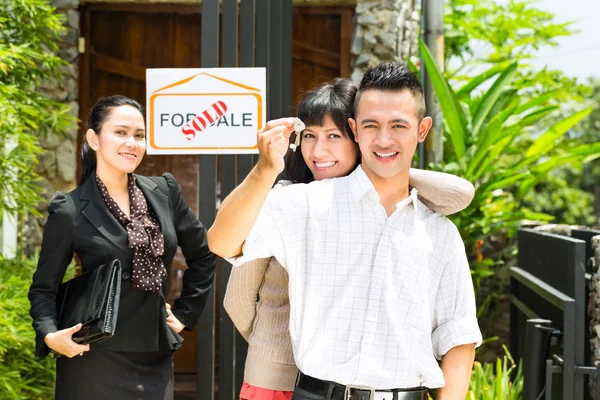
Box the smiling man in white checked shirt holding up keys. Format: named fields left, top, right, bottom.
left=208, top=63, right=481, bottom=400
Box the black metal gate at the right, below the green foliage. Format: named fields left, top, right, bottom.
left=510, top=229, right=600, bottom=400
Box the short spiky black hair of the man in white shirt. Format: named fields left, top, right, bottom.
left=354, top=62, right=426, bottom=120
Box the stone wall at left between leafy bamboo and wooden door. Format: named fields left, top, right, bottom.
left=23, top=0, right=79, bottom=254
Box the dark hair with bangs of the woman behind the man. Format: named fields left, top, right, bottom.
left=282, top=78, right=358, bottom=183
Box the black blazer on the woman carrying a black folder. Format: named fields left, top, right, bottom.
left=29, top=173, right=216, bottom=357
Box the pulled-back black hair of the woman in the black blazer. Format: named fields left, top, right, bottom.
left=78, top=94, right=144, bottom=185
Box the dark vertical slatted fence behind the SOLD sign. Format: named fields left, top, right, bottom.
left=196, top=0, right=292, bottom=400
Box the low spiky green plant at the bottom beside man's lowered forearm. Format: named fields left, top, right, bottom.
left=466, top=346, right=523, bottom=400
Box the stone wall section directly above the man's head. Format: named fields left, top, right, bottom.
left=351, top=0, right=419, bottom=82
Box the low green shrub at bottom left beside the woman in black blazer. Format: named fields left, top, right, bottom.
left=0, top=257, right=73, bottom=400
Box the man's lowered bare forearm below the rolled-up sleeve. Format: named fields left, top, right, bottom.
left=436, top=343, right=475, bottom=400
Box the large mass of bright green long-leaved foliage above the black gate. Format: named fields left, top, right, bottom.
left=432, top=0, right=600, bottom=359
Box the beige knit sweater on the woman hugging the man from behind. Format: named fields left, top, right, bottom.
left=224, top=169, right=474, bottom=391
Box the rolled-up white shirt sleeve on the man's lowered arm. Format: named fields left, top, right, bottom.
left=431, top=225, right=482, bottom=359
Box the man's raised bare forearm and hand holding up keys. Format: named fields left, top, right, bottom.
left=208, top=118, right=296, bottom=258
